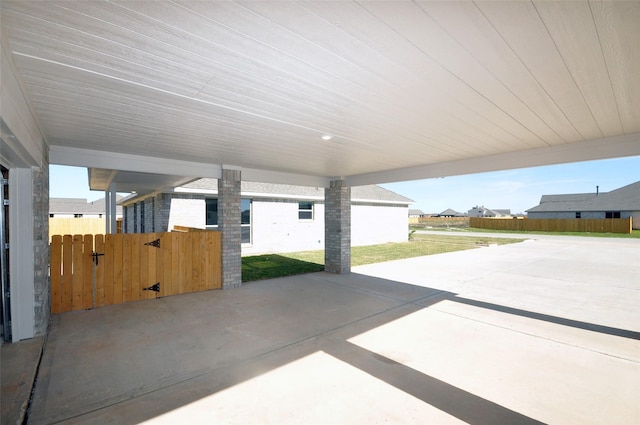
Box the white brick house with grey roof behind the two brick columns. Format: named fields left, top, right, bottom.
left=120, top=179, right=413, bottom=255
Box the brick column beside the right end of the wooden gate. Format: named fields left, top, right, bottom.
left=218, top=168, right=242, bottom=289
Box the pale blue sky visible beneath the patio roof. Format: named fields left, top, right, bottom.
left=50, top=156, right=640, bottom=213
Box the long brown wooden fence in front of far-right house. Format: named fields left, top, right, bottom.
left=469, top=217, right=633, bottom=234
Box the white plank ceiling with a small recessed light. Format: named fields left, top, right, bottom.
left=1, top=0, right=640, bottom=190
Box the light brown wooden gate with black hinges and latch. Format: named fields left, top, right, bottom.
left=50, top=231, right=222, bottom=314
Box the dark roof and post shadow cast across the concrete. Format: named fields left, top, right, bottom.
left=23, top=272, right=638, bottom=424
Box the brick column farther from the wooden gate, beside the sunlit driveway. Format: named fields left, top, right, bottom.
left=324, top=180, right=351, bottom=274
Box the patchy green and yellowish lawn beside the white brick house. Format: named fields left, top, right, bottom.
left=242, top=234, right=524, bottom=282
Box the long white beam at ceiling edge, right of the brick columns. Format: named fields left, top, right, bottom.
left=346, top=133, right=640, bottom=186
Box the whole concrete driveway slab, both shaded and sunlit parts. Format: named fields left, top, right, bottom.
left=28, top=237, right=640, bottom=424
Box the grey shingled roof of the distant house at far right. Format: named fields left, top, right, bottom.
left=527, top=181, right=640, bottom=212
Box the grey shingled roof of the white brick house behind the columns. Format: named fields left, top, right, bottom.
left=176, top=178, right=413, bottom=205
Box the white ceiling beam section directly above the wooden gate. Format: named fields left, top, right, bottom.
left=49, top=146, right=221, bottom=179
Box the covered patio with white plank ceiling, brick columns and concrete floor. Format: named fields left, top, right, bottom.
left=0, top=0, right=640, bottom=423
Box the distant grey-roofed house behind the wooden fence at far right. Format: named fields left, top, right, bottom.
left=527, top=181, right=640, bottom=229
